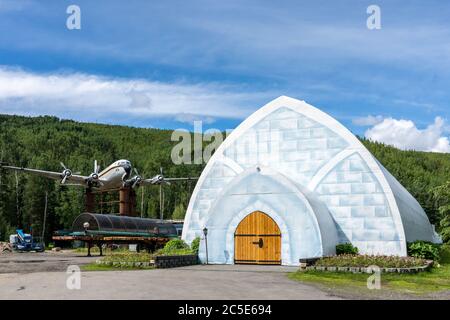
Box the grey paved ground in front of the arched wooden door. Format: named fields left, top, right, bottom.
left=0, top=265, right=336, bottom=300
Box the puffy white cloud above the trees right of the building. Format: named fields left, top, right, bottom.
left=365, top=117, right=450, bottom=153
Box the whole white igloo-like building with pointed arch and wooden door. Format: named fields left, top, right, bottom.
left=182, top=96, right=440, bottom=265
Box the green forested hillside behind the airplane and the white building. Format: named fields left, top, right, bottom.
left=0, top=115, right=450, bottom=240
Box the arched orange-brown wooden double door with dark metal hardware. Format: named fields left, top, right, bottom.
left=234, top=211, right=281, bottom=264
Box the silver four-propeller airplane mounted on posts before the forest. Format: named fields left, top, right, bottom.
left=0, top=159, right=197, bottom=191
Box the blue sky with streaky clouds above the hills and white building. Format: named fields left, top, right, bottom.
left=0, top=0, right=450, bottom=152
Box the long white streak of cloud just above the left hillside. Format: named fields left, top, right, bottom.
left=0, top=67, right=273, bottom=123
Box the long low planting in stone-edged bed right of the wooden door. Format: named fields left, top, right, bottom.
left=314, top=254, right=426, bottom=268
